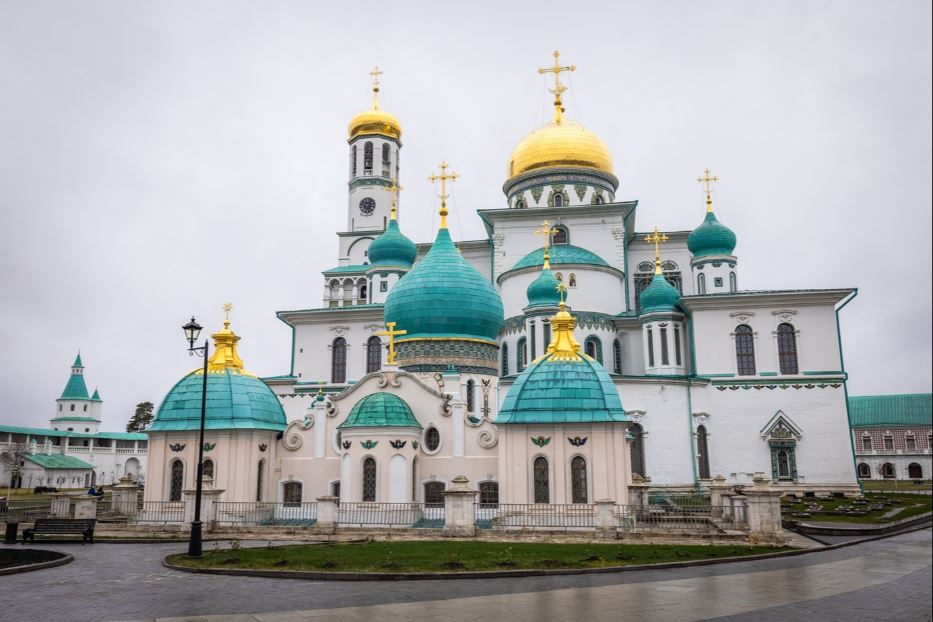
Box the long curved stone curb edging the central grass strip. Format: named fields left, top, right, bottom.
left=162, top=525, right=929, bottom=581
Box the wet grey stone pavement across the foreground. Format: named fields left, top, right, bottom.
left=0, top=529, right=933, bottom=622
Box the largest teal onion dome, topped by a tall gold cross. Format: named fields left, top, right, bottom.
left=385, top=228, right=505, bottom=342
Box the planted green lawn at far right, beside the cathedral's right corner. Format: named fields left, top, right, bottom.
left=781, top=493, right=933, bottom=525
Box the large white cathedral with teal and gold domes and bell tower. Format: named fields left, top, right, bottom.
left=145, top=52, right=858, bottom=504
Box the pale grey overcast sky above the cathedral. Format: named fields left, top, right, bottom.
left=0, top=0, right=931, bottom=430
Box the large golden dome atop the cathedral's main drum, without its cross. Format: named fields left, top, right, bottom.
left=508, top=119, right=613, bottom=179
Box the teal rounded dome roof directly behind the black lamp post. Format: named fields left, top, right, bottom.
left=147, top=367, right=287, bottom=432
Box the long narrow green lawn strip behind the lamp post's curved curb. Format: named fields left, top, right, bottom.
left=169, top=541, right=792, bottom=573
